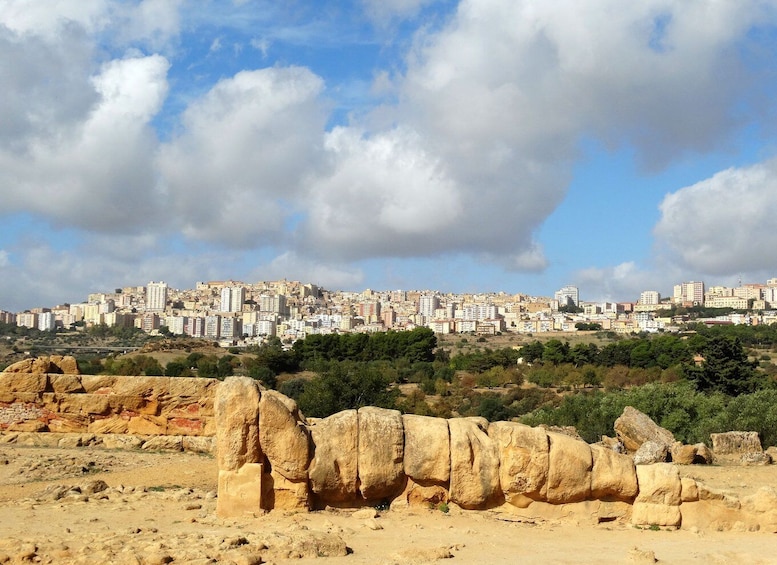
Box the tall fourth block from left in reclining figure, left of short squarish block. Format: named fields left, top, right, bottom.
left=358, top=406, right=405, bottom=500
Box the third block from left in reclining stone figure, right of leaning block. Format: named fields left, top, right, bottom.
left=308, top=410, right=359, bottom=504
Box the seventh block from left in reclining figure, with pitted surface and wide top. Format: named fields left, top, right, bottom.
left=488, top=422, right=550, bottom=508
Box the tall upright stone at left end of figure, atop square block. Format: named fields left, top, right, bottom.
left=215, top=377, right=263, bottom=471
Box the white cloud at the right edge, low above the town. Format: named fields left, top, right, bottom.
left=654, top=159, right=777, bottom=275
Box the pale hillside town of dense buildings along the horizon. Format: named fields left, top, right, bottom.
left=0, top=278, right=777, bottom=346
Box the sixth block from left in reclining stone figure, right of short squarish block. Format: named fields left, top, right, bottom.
left=448, top=418, right=502, bottom=509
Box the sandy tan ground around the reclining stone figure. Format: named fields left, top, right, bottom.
left=0, top=445, right=777, bottom=565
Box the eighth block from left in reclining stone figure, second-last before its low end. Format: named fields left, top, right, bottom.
left=547, top=432, right=593, bottom=504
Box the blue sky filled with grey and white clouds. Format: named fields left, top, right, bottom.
left=0, top=0, right=777, bottom=311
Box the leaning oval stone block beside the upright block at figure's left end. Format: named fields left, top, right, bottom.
left=259, top=390, right=310, bottom=481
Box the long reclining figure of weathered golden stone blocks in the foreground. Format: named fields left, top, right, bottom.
left=215, top=377, right=777, bottom=531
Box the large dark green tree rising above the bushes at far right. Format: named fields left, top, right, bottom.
left=683, top=335, right=762, bottom=396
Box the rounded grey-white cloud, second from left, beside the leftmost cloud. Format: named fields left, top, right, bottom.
left=159, top=67, right=326, bottom=247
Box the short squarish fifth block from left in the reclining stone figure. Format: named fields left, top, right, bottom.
left=402, top=414, right=451, bottom=484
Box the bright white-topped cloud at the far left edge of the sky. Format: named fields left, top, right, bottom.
left=0, top=51, right=169, bottom=232
